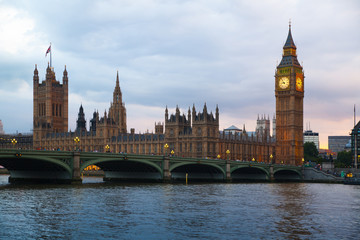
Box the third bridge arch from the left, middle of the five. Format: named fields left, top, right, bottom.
left=169, top=162, right=226, bottom=181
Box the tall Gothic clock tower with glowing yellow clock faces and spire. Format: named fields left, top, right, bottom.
left=275, top=25, right=304, bottom=165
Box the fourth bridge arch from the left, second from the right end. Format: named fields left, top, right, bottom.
left=230, top=165, right=270, bottom=182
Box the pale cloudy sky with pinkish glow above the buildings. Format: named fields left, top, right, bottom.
left=0, top=0, right=360, bottom=148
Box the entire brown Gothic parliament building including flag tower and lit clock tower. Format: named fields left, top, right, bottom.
left=6, top=26, right=304, bottom=165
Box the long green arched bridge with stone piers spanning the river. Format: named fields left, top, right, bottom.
left=0, top=149, right=303, bottom=183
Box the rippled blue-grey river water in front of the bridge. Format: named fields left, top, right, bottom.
left=0, top=175, right=360, bottom=240
